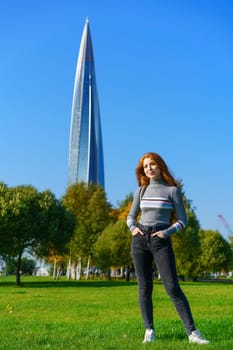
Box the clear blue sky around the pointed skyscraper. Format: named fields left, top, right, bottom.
left=0, top=0, right=233, bottom=237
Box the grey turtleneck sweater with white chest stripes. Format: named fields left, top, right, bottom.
left=127, top=179, right=187, bottom=238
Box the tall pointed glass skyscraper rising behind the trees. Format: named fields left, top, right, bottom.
left=68, top=19, right=104, bottom=188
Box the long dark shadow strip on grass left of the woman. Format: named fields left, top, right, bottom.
left=0, top=278, right=137, bottom=288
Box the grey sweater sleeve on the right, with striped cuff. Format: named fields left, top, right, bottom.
left=163, top=186, right=188, bottom=238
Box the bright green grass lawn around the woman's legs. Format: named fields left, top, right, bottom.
left=0, top=277, right=233, bottom=350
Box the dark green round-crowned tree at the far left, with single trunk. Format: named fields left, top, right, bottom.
left=0, top=184, right=75, bottom=285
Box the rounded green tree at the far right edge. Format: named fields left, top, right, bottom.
left=199, top=230, right=232, bottom=276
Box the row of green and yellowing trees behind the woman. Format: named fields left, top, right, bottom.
left=0, top=183, right=233, bottom=284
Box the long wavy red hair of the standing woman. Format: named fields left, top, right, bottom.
left=135, top=152, right=177, bottom=186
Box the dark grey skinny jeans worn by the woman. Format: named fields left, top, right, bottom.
left=131, top=225, right=195, bottom=335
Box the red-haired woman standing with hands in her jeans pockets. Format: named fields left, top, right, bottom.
left=127, top=153, right=209, bottom=344
